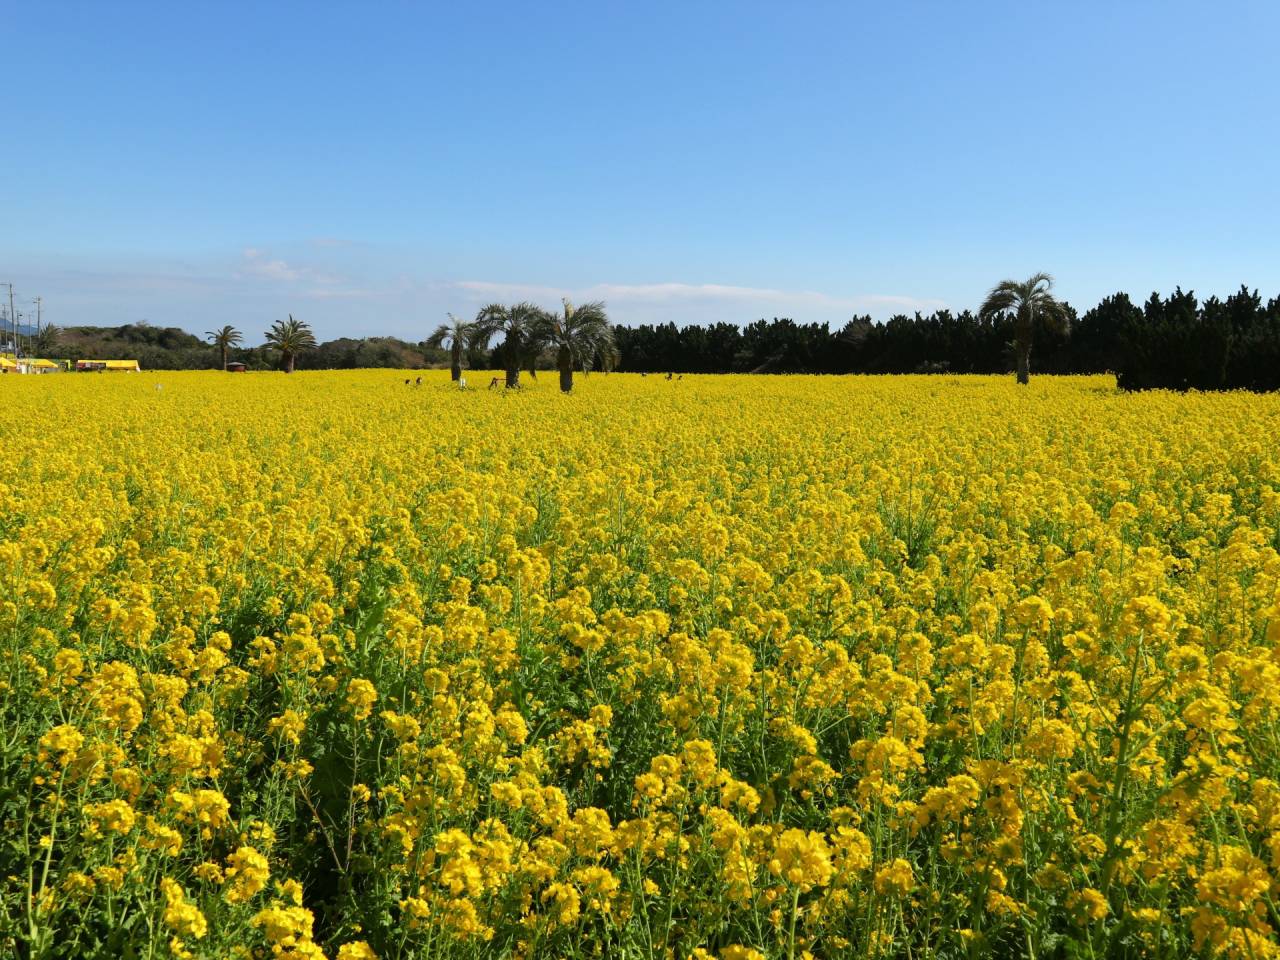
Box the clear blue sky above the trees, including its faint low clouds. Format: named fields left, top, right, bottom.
left=0, top=0, right=1280, bottom=339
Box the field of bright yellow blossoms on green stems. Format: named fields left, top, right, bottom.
left=0, top=371, right=1280, bottom=960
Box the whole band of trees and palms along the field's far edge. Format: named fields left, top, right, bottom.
left=42, top=280, right=1280, bottom=390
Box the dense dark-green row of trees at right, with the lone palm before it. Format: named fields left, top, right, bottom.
left=616, top=284, right=1280, bottom=390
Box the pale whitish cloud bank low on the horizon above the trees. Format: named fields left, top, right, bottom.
left=5, top=243, right=946, bottom=339
